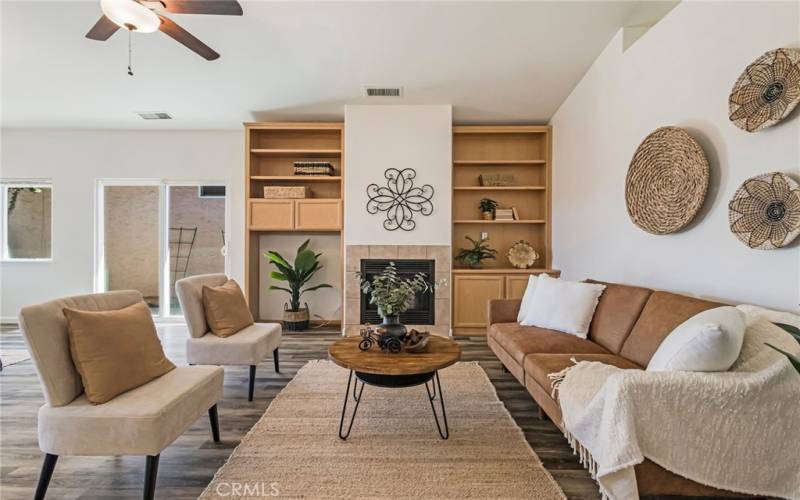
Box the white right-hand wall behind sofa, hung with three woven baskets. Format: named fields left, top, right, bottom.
left=551, top=2, right=800, bottom=310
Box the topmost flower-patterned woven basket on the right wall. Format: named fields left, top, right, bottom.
left=728, top=49, right=800, bottom=132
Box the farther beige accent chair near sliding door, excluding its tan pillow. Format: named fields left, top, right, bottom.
left=175, top=274, right=281, bottom=401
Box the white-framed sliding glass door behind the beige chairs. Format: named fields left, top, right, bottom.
left=95, top=180, right=227, bottom=318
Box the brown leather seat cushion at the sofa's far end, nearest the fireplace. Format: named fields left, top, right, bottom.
left=489, top=323, right=608, bottom=365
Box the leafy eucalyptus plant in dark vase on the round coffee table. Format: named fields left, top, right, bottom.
left=356, top=262, right=436, bottom=338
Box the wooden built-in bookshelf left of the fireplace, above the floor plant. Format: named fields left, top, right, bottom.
left=245, top=123, right=344, bottom=321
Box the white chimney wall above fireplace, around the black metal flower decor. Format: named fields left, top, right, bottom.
left=344, top=106, right=453, bottom=246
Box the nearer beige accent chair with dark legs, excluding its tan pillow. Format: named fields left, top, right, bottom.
left=19, top=291, right=223, bottom=500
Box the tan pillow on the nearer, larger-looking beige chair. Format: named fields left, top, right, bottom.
left=63, top=302, right=175, bottom=403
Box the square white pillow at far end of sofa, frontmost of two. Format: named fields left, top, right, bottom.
left=520, top=275, right=606, bottom=339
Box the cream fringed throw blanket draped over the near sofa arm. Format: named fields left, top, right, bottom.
left=551, top=319, right=800, bottom=500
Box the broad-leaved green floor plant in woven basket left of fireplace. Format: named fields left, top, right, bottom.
left=264, top=240, right=333, bottom=331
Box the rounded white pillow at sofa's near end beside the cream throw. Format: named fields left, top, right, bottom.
left=647, top=306, right=746, bottom=372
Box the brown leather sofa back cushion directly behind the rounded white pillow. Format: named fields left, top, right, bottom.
left=619, top=292, right=725, bottom=366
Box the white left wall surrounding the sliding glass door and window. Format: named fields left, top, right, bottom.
left=0, top=129, right=244, bottom=319
